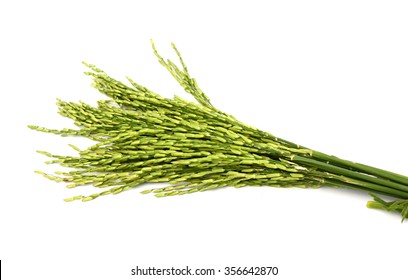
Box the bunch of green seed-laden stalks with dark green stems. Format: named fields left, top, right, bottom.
left=29, top=42, right=408, bottom=219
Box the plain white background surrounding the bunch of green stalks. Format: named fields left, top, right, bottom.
left=0, top=0, right=408, bottom=280
